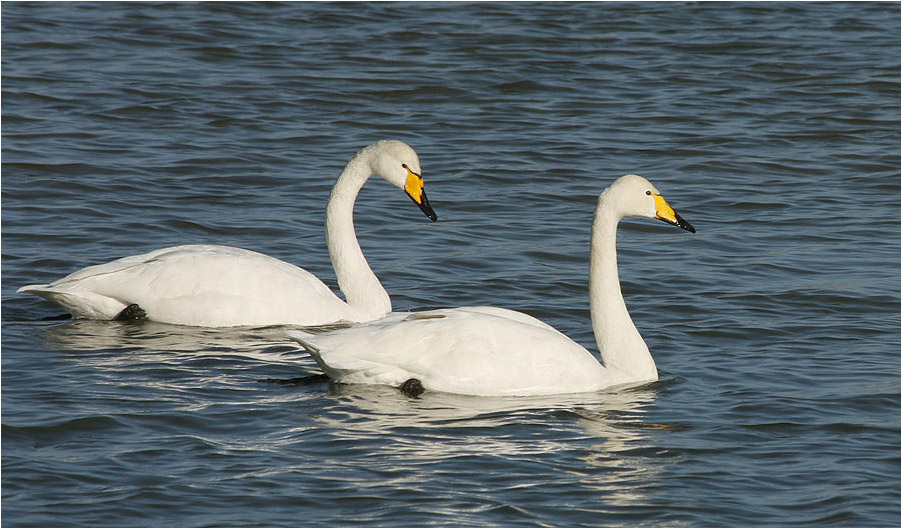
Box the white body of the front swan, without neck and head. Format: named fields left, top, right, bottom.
left=301, top=307, right=611, bottom=396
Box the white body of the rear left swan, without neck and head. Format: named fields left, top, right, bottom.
left=20, top=245, right=347, bottom=327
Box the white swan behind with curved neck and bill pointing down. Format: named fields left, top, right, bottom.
left=18, top=140, right=436, bottom=327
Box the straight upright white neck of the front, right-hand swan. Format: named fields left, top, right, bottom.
left=589, top=194, right=658, bottom=382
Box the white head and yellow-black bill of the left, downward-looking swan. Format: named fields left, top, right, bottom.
left=369, top=140, right=438, bottom=220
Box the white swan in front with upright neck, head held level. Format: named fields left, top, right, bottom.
left=287, top=175, right=695, bottom=396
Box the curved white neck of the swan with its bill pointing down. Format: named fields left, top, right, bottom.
left=326, top=151, right=391, bottom=321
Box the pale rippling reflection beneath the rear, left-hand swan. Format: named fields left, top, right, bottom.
left=30, top=319, right=332, bottom=396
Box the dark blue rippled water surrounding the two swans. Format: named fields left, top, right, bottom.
left=2, top=2, right=900, bottom=526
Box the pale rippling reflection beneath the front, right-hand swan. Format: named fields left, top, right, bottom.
left=308, top=379, right=673, bottom=506
